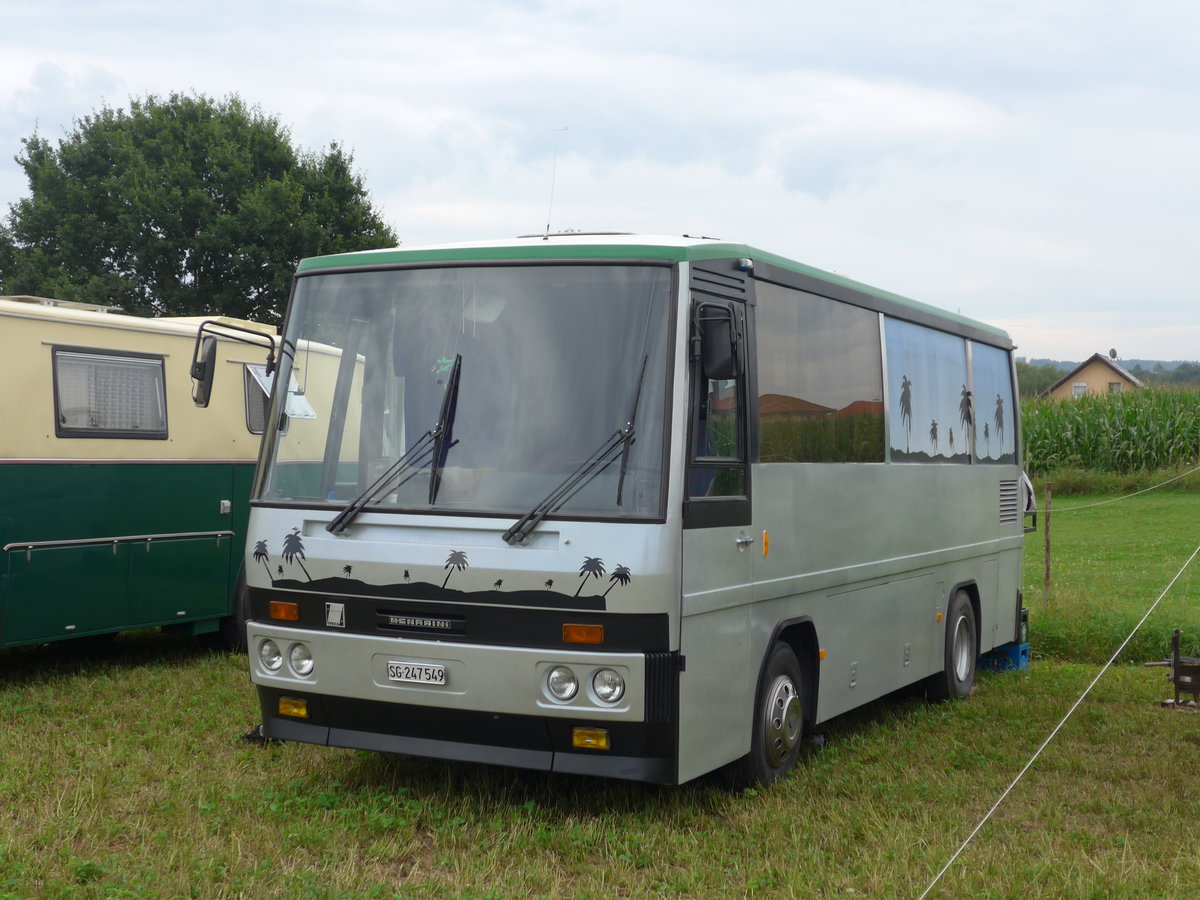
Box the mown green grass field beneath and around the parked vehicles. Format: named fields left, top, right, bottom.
left=0, top=494, right=1200, bottom=898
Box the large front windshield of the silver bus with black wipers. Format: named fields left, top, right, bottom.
left=258, top=264, right=673, bottom=526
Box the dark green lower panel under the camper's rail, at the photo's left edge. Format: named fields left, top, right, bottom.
left=2, top=544, right=130, bottom=646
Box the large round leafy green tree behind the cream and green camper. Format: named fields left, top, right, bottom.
left=0, top=94, right=396, bottom=322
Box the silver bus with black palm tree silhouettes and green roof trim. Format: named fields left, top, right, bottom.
left=211, top=234, right=1025, bottom=785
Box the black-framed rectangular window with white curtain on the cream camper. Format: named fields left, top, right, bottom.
left=53, top=347, right=167, bottom=440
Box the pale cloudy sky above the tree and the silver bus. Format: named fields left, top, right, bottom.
left=0, top=0, right=1200, bottom=361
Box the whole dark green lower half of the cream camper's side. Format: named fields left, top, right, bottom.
left=0, top=461, right=253, bottom=646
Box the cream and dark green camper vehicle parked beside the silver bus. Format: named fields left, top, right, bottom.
left=0, top=296, right=276, bottom=647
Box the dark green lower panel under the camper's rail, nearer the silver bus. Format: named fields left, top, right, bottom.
left=126, top=538, right=240, bottom=628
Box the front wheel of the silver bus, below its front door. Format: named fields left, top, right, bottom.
left=727, top=641, right=804, bottom=788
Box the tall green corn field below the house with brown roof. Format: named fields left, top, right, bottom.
left=1021, top=389, right=1200, bottom=476
